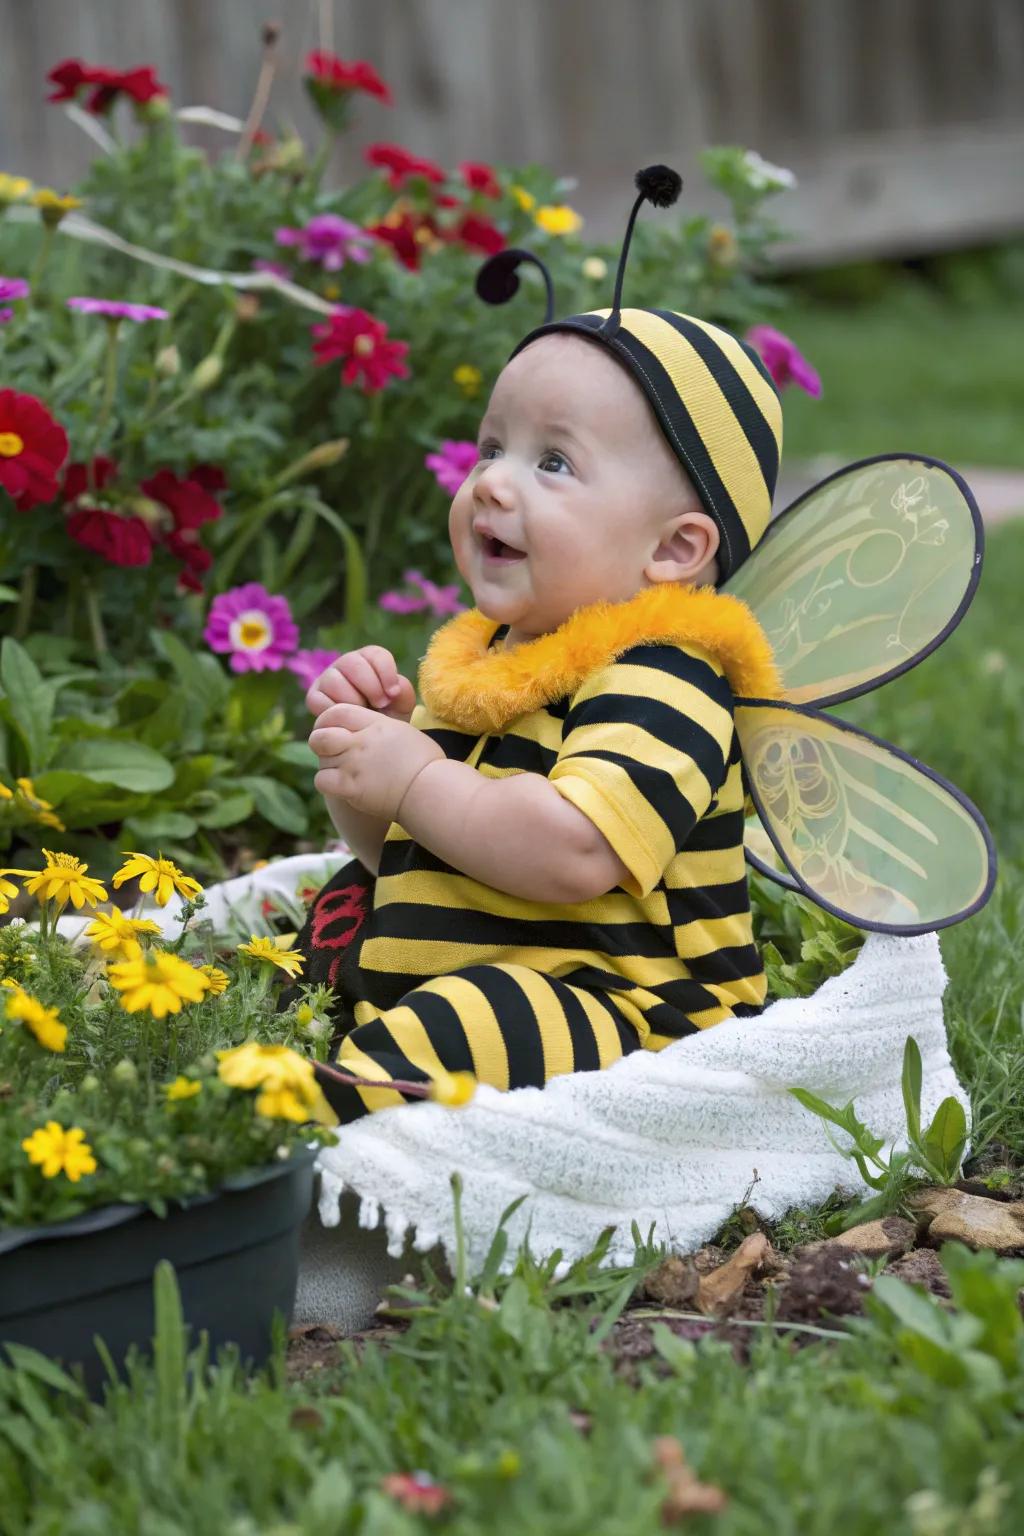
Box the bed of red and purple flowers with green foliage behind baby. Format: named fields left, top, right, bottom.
left=0, top=28, right=808, bottom=879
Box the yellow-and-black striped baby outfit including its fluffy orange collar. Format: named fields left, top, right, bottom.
left=316, top=587, right=771, bottom=1120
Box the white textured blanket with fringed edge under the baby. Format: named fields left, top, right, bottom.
left=61, top=851, right=969, bottom=1281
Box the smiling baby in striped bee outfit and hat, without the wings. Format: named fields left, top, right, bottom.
left=304, top=176, right=780, bottom=1121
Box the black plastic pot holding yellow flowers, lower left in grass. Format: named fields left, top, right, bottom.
left=0, top=1152, right=315, bottom=1393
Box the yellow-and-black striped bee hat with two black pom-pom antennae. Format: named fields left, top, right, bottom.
left=476, top=166, right=783, bottom=581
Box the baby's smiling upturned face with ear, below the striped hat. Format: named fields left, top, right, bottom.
left=448, top=333, right=714, bottom=645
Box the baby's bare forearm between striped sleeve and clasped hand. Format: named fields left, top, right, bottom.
left=396, top=759, right=628, bottom=903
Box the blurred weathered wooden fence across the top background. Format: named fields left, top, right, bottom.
left=0, top=0, right=1024, bottom=261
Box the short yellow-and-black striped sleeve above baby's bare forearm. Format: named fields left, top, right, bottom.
left=548, top=644, right=732, bottom=897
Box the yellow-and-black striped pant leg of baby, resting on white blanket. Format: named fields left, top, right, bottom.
left=322, top=965, right=646, bottom=1123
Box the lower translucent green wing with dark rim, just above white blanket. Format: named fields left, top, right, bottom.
left=735, top=699, right=995, bottom=934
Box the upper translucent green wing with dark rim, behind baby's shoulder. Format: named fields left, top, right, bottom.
left=725, top=453, right=983, bottom=705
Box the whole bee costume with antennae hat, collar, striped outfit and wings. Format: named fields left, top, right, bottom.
left=299, top=166, right=995, bottom=1121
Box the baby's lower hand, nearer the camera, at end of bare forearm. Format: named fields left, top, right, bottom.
left=309, top=703, right=444, bottom=822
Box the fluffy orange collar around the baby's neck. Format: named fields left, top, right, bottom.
left=419, top=582, right=781, bottom=734
